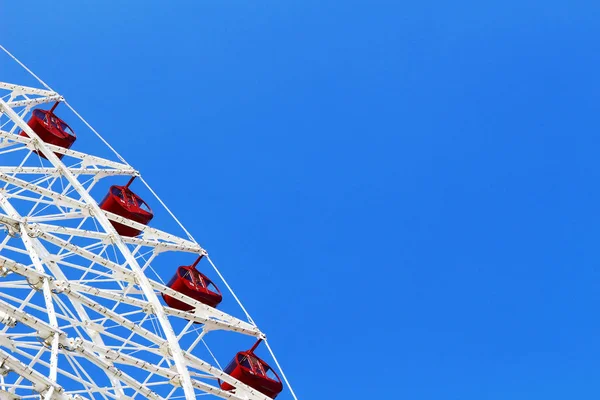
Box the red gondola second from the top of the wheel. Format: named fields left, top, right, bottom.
left=100, top=177, right=154, bottom=237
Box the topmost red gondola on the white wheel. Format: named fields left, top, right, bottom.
left=21, top=102, right=77, bottom=158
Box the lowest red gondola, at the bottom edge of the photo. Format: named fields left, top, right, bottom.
left=220, top=339, right=283, bottom=399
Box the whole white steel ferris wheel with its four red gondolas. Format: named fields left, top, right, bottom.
left=0, top=46, right=296, bottom=400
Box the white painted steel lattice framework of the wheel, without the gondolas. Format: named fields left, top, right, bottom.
left=0, top=46, right=296, bottom=400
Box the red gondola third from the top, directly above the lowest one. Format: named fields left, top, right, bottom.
left=162, top=256, right=223, bottom=311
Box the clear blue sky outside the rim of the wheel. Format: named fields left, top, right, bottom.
left=0, top=0, right=600, bottom=400
